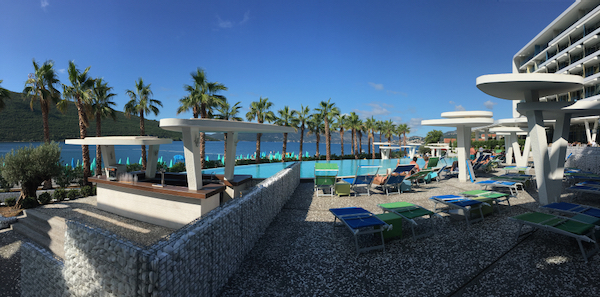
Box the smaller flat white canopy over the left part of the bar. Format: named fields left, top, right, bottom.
left=65, top=136, right=173, bottom=178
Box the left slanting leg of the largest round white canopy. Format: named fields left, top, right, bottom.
left=526, top=110, right=561, bottom=205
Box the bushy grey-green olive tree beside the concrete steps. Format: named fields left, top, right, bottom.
left=0, top=142, right=60, bottom=206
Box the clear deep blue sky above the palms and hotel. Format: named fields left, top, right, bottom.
left=0, top=0, right=574, bottom=136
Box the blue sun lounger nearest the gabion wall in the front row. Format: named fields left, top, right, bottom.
left=329, top=207, right=390, bottom=254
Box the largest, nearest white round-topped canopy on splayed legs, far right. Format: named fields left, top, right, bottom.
left=477, top=73, right=600, bottom=205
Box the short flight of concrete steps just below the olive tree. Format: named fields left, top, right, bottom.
left=13, top=209, right=66, bottom=258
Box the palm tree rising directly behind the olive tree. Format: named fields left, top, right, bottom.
left=23, top=59, right=60, bottom=142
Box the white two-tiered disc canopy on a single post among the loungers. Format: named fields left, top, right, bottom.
left=421, top=111, right=494, bottom=182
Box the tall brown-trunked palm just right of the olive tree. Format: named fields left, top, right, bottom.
left=60, top=61, right=94, bottom=184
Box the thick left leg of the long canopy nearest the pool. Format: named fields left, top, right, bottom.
left=181, top=127, right=203, bottom=191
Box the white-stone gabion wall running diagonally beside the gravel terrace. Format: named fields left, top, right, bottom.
left=21, top=163, right=300, bottom=296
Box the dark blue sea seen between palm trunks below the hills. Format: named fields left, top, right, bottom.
left=0, top=141, right=398, bottom=166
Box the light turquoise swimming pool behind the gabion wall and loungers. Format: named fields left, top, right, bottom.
left=202, top=158, right=456, bottom=179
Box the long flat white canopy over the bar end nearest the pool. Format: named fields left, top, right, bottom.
left=160, top=118, right=295, bottom=190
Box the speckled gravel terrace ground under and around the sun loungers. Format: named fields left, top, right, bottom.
left=221, top=172, right=600, bottom=296
